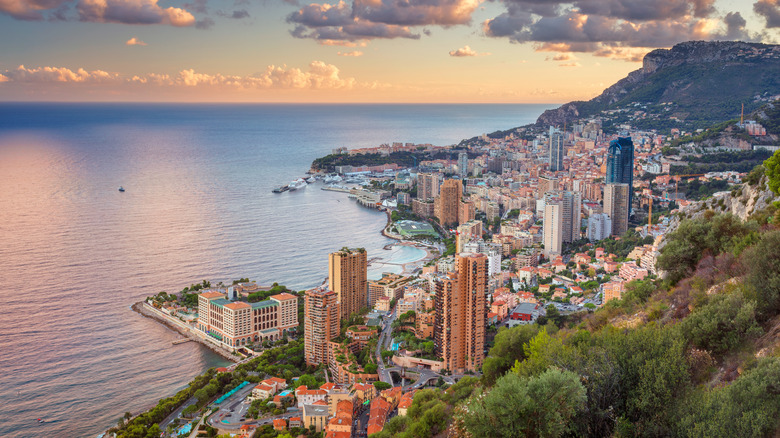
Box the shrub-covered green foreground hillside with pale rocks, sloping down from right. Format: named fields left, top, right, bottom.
left=382, top=152, right=780, bottom=438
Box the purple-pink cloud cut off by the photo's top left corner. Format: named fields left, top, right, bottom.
left=0, top=0, right=195, bottom=27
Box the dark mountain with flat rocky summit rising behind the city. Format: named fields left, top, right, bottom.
left=536, top=41, right=780, bottom=129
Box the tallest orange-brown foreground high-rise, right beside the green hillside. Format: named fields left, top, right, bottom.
left=433, top=254, right=488, bottom=372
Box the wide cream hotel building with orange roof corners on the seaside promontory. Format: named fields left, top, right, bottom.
left=197, top=291, right=298, bottom=349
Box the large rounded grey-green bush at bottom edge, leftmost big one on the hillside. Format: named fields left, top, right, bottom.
left=463, top=368, right=586, bottom=438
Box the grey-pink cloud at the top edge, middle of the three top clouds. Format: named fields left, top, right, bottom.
left=287, top=0, right=483, bottom=41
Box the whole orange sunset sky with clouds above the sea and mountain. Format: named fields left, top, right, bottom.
left=0, top=0, right=780, bottom=103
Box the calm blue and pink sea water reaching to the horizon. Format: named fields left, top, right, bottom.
left=0, top=104, right=550, bottom=437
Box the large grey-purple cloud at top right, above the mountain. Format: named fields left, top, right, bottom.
left=482, top=0, right=764, bottom=61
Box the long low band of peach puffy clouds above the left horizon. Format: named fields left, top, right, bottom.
left=0, top=61, right=362, bottom=90
